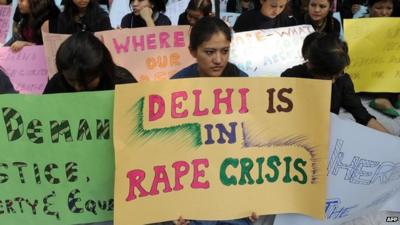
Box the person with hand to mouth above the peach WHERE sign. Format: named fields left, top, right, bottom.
left=121, top=0, right=171, bottom=28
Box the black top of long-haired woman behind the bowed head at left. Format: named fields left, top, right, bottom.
left=56, top=7, right=112, bottom=34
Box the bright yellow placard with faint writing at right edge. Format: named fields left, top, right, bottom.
left=344, top=18, right=400, bottom=92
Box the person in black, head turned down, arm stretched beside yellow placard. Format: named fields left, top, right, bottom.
left=281, top=32, right=388, bottom=133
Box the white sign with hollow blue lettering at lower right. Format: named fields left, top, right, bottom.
left=274, top=114, right=400, bottom=225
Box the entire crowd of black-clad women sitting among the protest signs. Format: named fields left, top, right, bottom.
left=0, top=0, right=400, bottom=222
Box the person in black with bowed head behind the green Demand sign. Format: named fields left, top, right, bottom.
left=44, top=31, right=136, bottom=94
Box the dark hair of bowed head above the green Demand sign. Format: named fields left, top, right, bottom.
left=56, top=31, right=116, bottom=87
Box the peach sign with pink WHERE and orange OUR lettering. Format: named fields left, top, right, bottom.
left=102, top=26, right=194, bottom=81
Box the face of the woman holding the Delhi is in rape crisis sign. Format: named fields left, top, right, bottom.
left=190, top=32, right=230, bottom=77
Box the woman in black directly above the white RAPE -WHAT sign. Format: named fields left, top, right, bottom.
left=233, top=0, right=297, bottom=32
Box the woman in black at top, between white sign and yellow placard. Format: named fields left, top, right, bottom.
left=298, top=0, right=340, bottom=36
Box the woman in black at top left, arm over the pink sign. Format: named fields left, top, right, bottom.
left=5, top=0, right=60, bottom=52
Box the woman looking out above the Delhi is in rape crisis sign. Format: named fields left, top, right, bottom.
left=171, top=17, right=248, bottom=79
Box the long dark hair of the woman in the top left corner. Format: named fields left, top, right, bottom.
left=17, top=0, right=60, bottom=44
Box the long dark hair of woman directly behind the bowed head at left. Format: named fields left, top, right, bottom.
left=63, top=0, right=106, bottom=32
